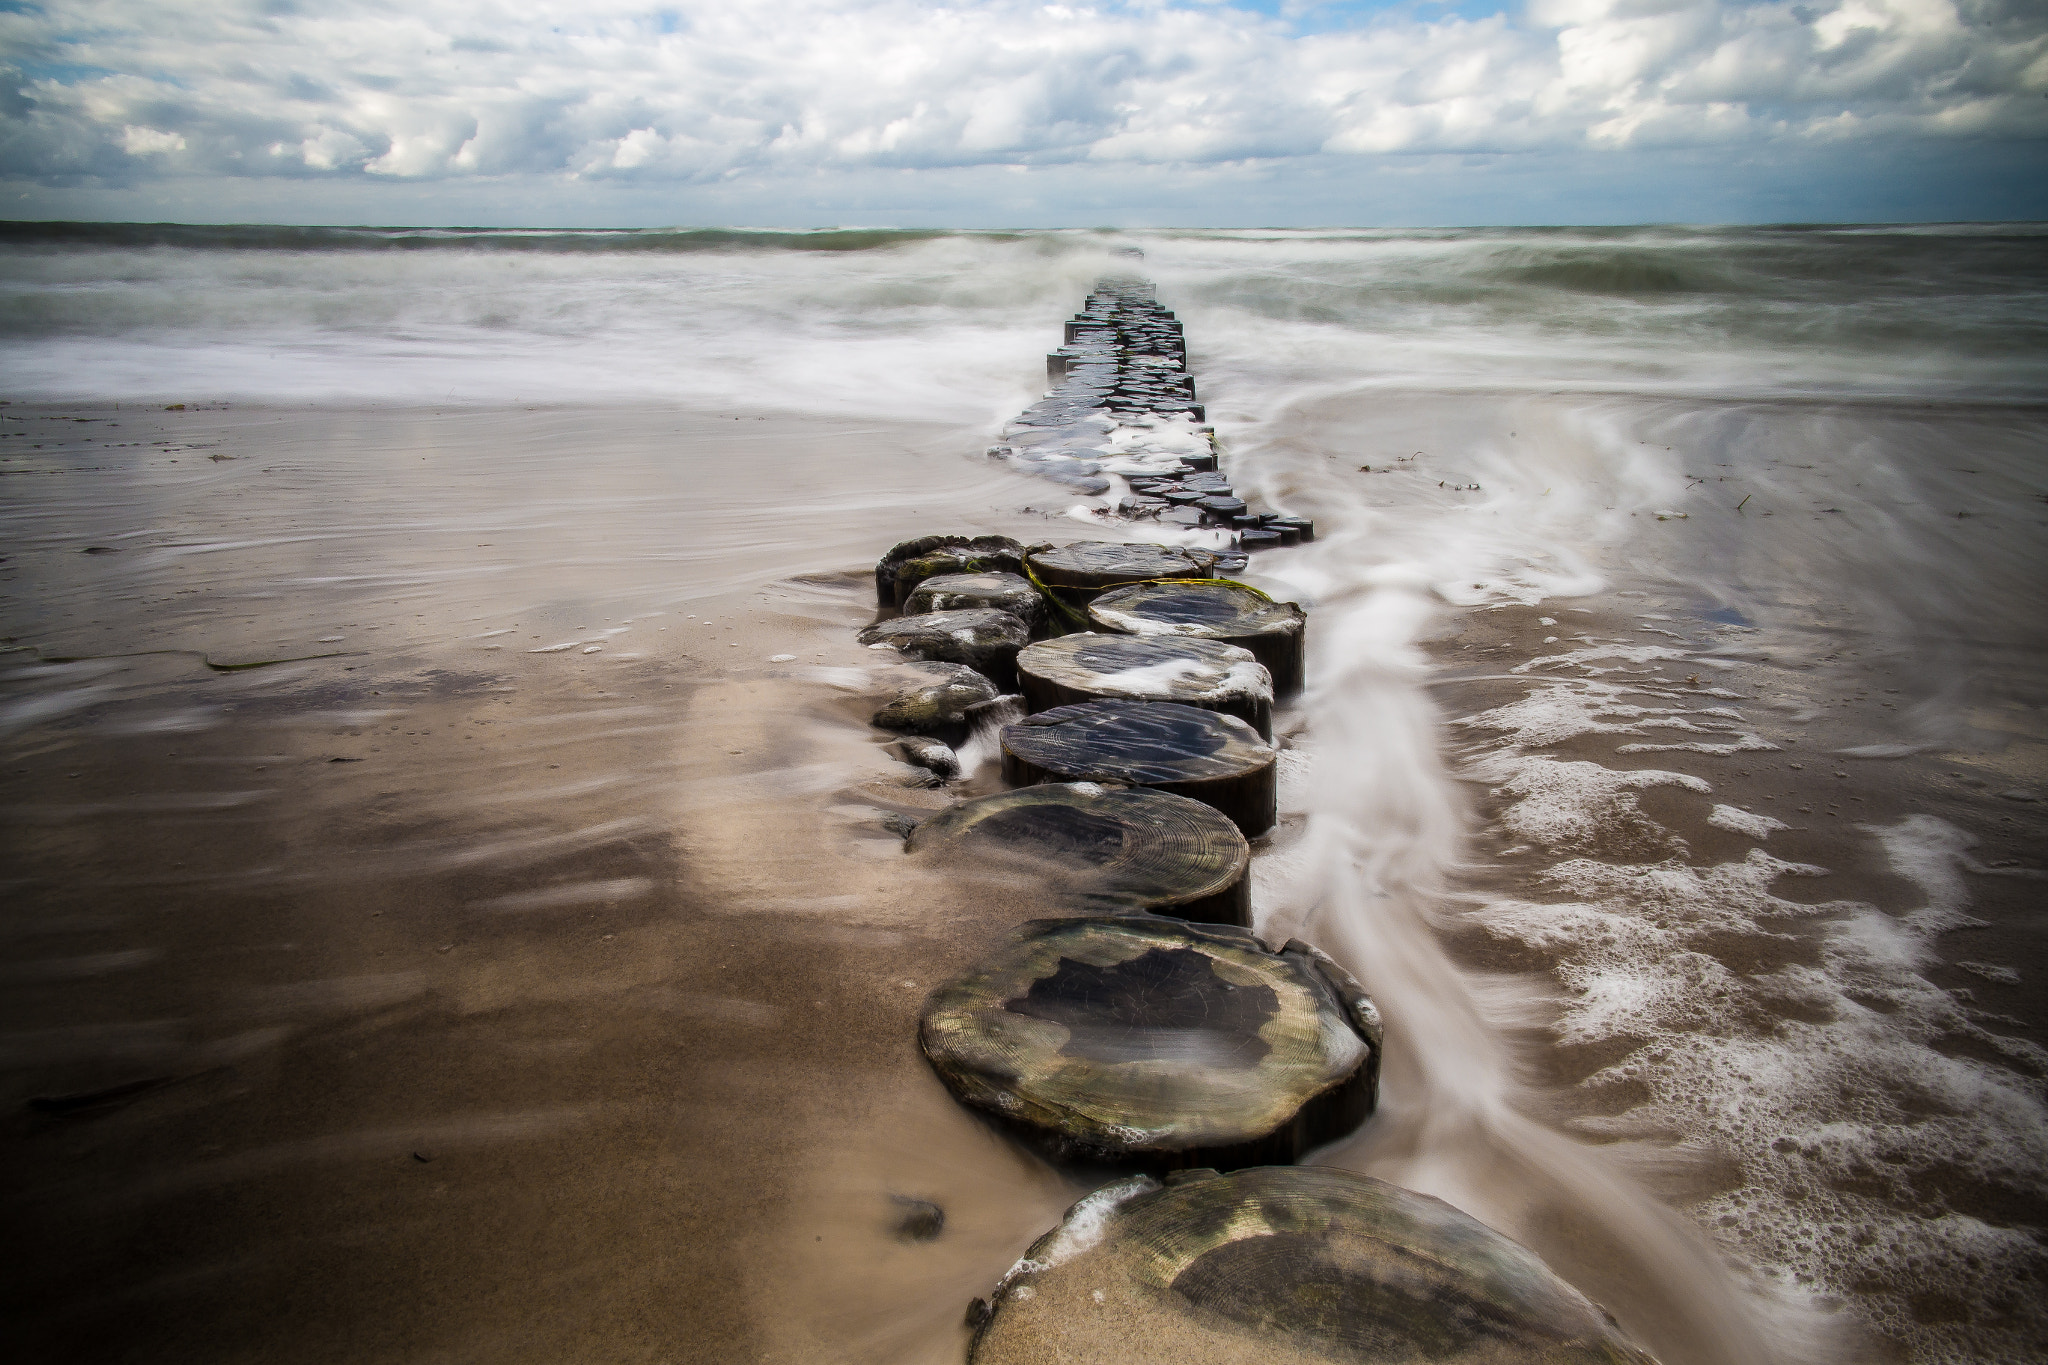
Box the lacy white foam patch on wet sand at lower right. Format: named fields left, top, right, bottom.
left=1479, top=817, right=2048, bottom=1359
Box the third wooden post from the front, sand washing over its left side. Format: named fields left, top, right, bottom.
left=905, top=782, right=1251, bottom=927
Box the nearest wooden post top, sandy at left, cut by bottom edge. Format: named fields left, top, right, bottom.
left=969, top=1166, right=1655, bottom=1365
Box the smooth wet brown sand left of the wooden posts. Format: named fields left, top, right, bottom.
left=0, top=405, right=1067, bottom=1361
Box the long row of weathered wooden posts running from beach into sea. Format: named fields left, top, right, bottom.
left=860, top=280, right=1655, bottom=1365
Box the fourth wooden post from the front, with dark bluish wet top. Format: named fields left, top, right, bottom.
left=1001, top=700, right=1280, bottom=839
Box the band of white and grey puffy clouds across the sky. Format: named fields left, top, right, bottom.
left=0, top=0, right=2048, bottom=184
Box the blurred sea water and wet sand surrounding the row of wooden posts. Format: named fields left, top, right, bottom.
left=0, top=229, right=2048, bottom=1363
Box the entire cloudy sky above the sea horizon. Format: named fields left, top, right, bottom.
left=0, top=0, right=2048, bottom=227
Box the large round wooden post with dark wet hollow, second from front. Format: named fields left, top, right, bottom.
left=918, top=915, right=1380, bottom=1169
